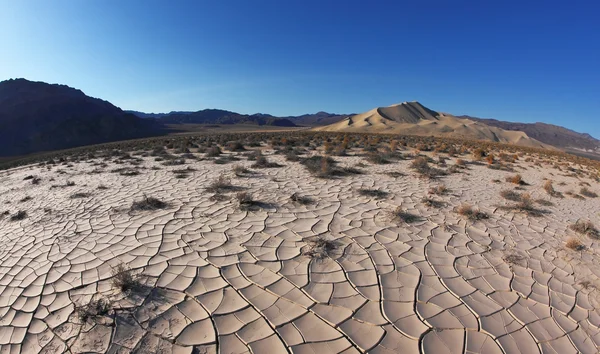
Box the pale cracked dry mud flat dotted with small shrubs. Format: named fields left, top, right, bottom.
left=0, top=151, right=600, bottom=354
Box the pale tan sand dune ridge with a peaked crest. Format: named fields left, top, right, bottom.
left=314, top=101, right=552, bottom=148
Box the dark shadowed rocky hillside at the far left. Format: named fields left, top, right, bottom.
left=0, top=79, right=162, bottom=156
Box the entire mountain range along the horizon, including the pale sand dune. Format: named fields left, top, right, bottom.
left=0, top=79, right=600, bottom=156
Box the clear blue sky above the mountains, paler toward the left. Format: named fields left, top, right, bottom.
left=0, top=0, right=600, bottom=138
